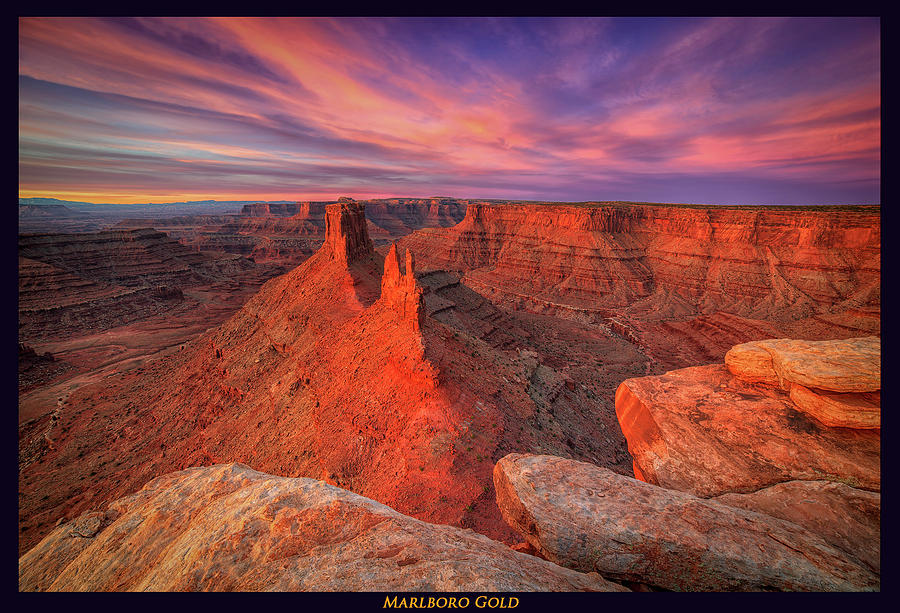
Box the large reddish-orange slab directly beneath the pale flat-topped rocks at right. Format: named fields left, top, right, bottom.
left=616, top=365, right=881, bottom=497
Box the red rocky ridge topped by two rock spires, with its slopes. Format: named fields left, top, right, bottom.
left=20, top=201, right=642, bottom=548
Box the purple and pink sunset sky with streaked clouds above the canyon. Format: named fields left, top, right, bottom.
left=18, top=17, right=881, bottom=204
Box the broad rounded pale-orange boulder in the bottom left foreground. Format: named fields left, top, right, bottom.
left=19, top=464, right=625, bottom=591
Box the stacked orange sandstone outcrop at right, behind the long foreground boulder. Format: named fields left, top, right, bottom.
left=616, top=339, right=881, bottom=574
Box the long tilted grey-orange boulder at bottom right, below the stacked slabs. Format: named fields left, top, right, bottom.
left=494, top=454, right=879, bottom=591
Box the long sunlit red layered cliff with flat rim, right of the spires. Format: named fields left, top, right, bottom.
left=397, top=203, right=881, bottom=368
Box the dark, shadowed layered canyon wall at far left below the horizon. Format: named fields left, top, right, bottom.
left=18, top=229, right=280, bottom=342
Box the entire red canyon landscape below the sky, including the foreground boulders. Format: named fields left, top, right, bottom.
left=19, top=197, right=881, bottom=591
